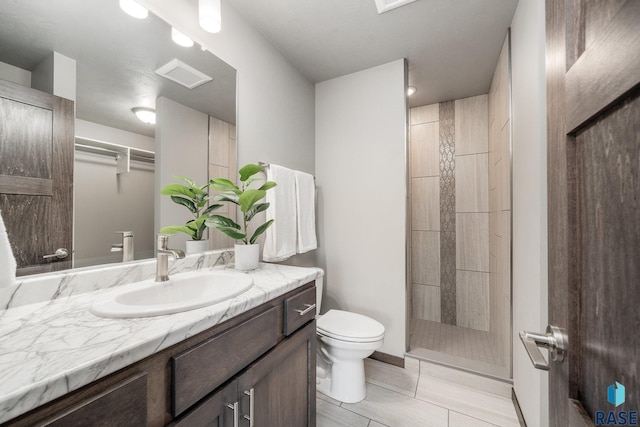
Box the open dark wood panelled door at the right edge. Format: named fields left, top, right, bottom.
left=546, top=0, right=640, bottom=426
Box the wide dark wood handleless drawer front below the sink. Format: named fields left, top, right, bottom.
left=171, top=307, right=278, bottom=417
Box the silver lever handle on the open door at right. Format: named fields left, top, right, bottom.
left=519, top=325, right=569, bottom=371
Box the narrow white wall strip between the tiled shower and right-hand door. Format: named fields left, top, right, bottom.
left=511, top=0, right=549, bottom=426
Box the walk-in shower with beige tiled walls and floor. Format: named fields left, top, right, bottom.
left=408, top=37, right=511, bottom=378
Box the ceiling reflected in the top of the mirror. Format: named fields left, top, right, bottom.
left=0, top=0, right=236, bottom=137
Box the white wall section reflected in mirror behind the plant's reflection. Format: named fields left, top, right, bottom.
left=154, top=97, right=209, bottom=250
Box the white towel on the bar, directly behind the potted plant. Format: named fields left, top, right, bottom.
left=262, top=165, right=296, bottom=262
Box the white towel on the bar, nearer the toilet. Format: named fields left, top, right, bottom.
left=295, top=171, right=318, bottom=254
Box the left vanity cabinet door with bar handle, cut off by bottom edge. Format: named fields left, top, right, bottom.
left=169, top=380, right=240, bottom=427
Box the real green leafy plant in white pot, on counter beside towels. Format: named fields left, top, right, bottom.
left=205, top=163, right=276, bottom=270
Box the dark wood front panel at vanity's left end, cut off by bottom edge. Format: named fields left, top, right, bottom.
left=42, top=373, right=147, bottom=427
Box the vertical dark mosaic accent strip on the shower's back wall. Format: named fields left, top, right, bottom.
left=440, top=101, right=456, bottom=325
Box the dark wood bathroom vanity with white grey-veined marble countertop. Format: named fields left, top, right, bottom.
left=0, top=258, right=322, bottom=427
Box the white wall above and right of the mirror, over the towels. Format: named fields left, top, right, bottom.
left=140, top=0, right=314, bottom=173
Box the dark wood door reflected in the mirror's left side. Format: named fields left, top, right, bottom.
left=0, top=80, right=74, bottom=275
